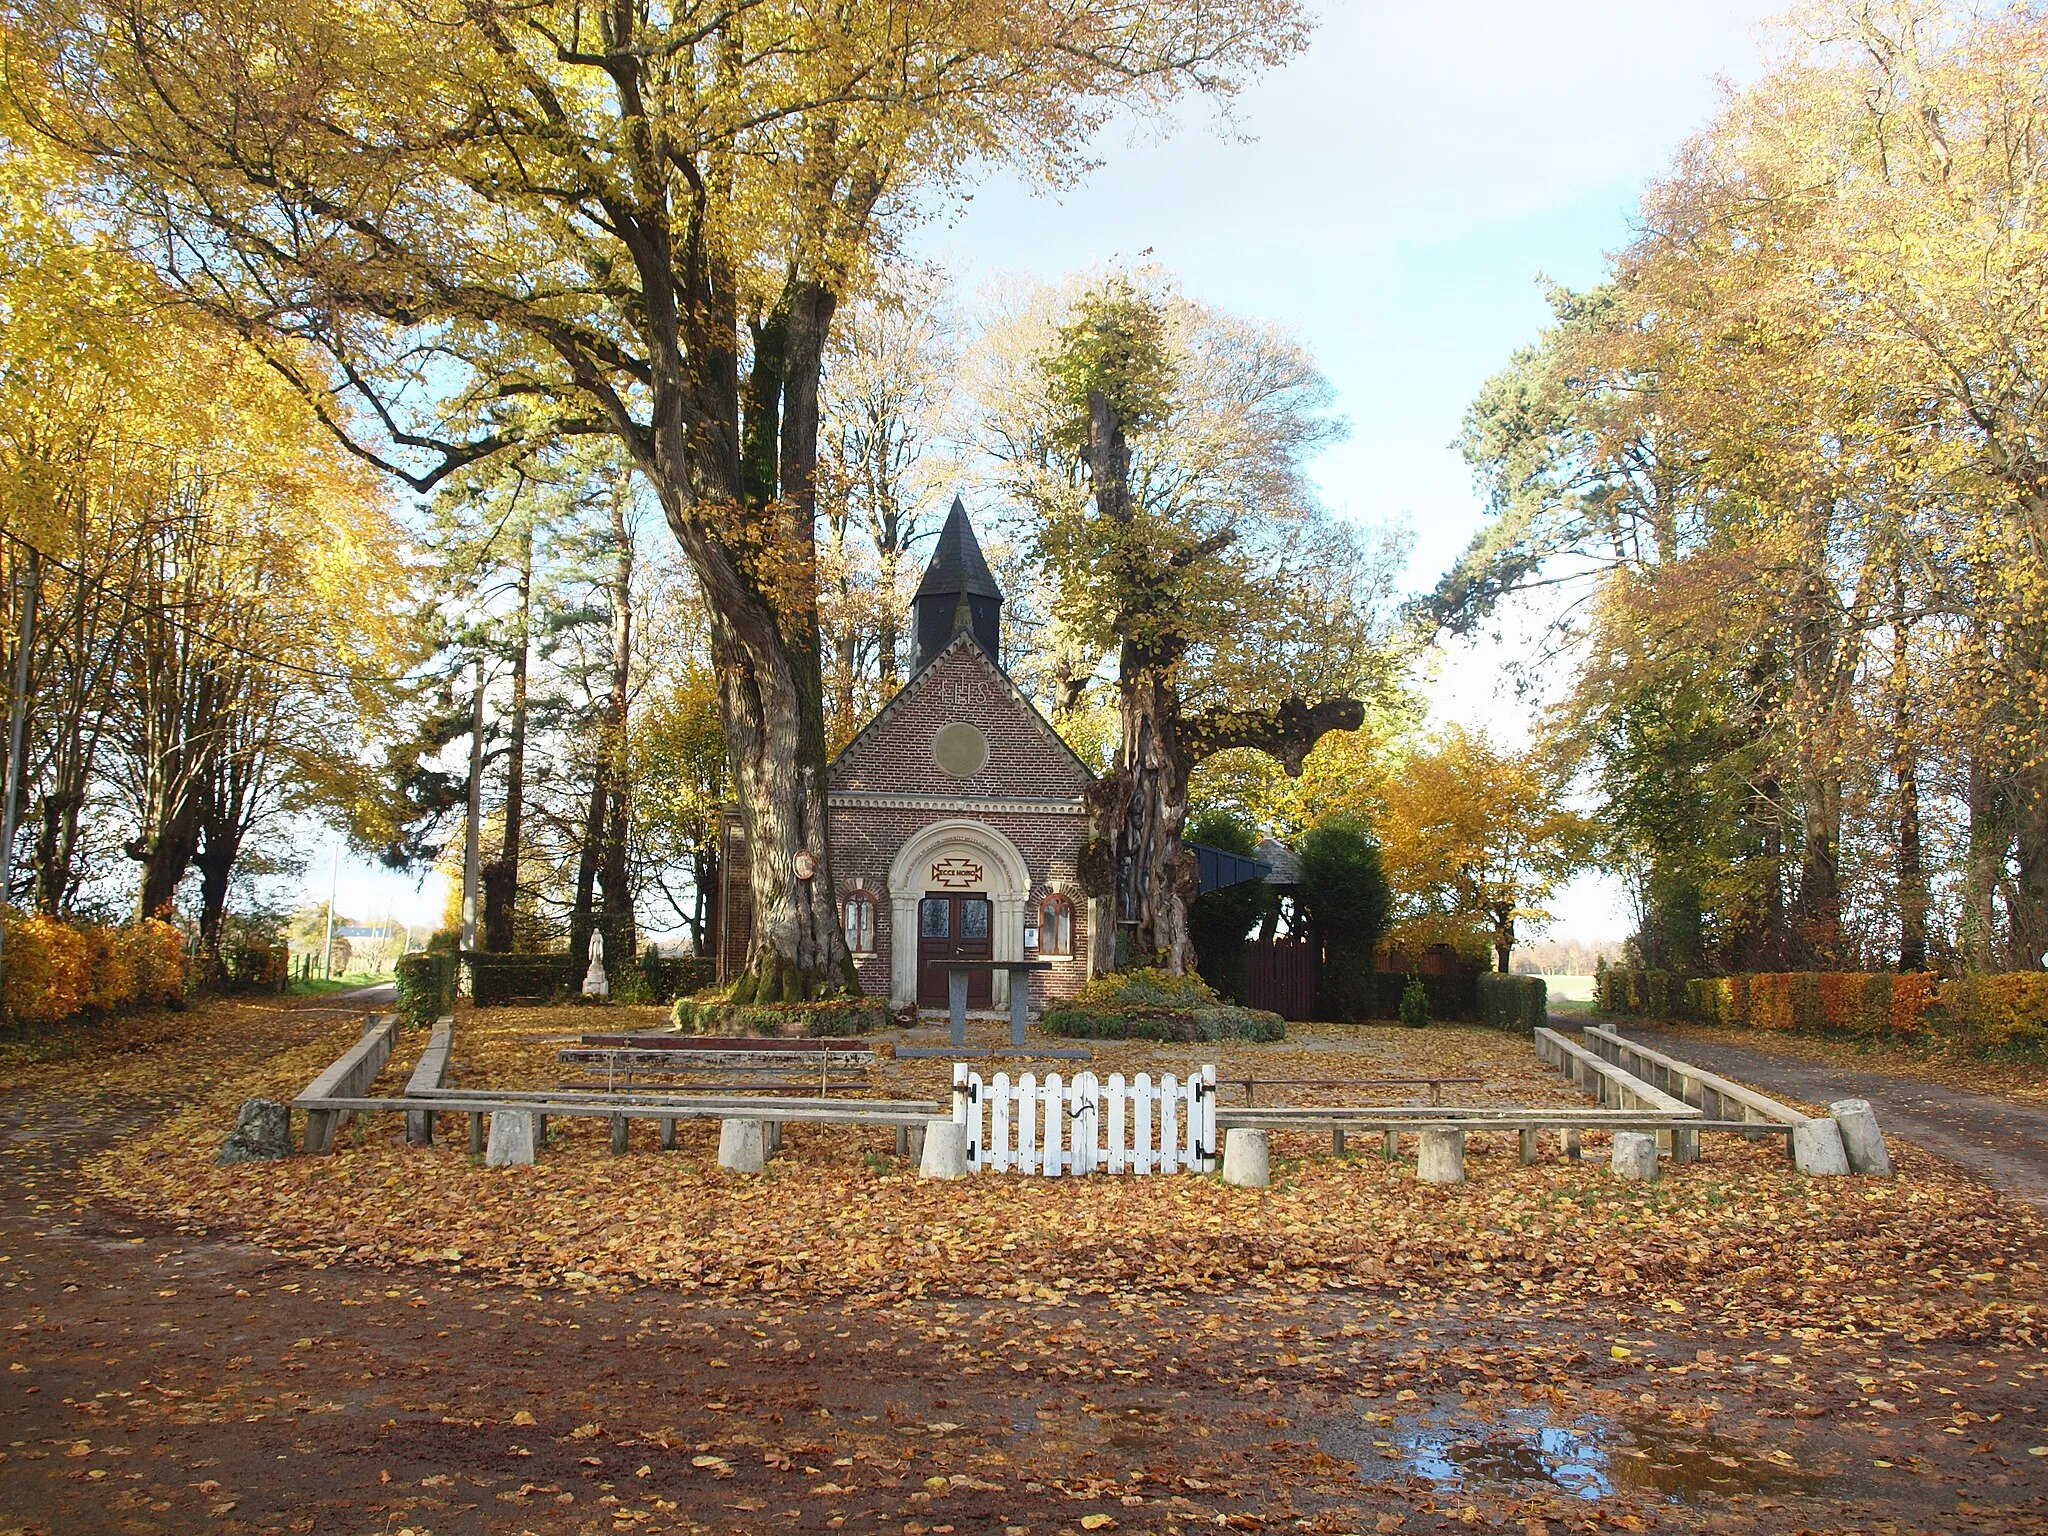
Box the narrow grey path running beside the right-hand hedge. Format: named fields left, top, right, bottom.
left=1622, top=1020, right=2048, bottom=1210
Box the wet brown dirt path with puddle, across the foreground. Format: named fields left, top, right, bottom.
left=0, top=999, right=2048, bottom=1536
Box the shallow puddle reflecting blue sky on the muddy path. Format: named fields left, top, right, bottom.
left=1319, top=1407, right=1823, bottom=1501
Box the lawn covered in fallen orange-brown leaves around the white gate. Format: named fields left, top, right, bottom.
left=90, top=1010, right=2048, bottom=1368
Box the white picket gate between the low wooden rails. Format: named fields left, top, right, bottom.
left=952, top=1061, right=1219, bottom=1178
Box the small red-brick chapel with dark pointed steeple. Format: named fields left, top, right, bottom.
left=717, top=498, right=1092, bottom=1008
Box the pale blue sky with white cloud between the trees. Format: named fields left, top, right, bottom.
left=305, top=0, right=1782, bottom=938
